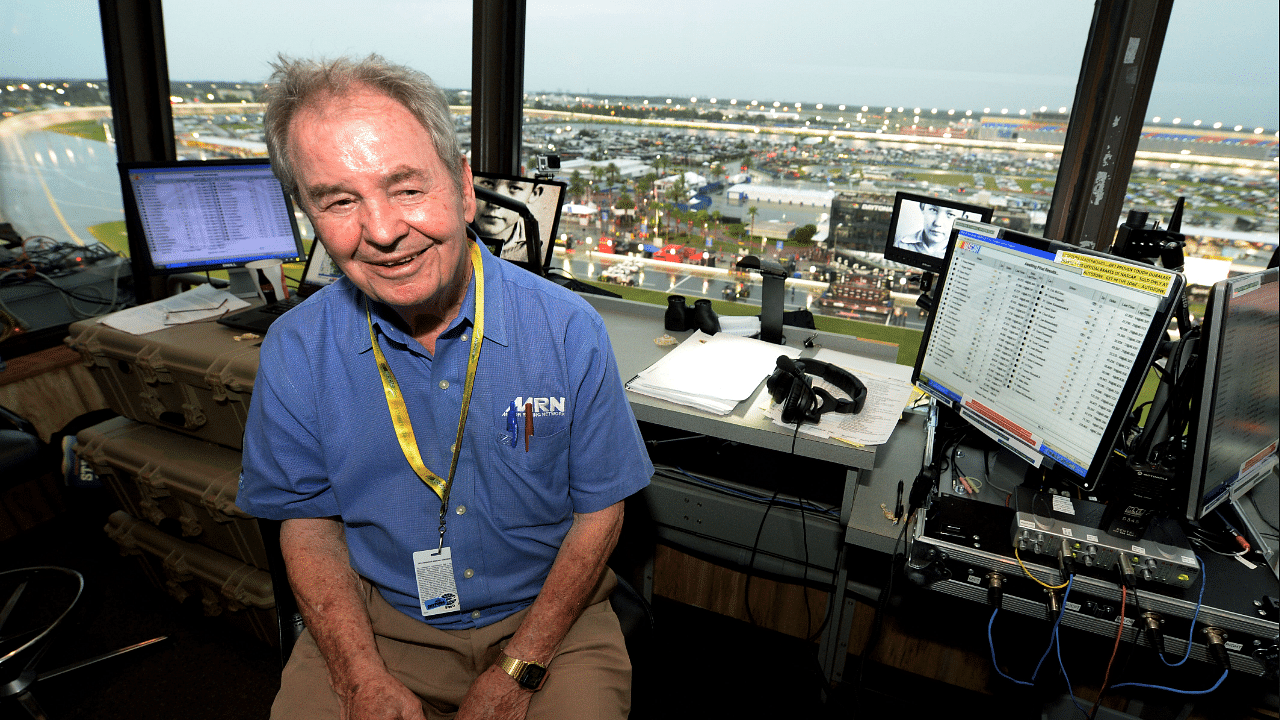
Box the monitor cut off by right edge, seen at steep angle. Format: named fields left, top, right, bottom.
left=1187, top=268, right=1280, bottom=520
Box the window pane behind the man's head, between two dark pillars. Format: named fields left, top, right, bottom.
left=164, top=0, right=472, bottom=250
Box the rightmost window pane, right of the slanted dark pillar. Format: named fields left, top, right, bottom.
left=1119, top=0, right=1280, bottom=283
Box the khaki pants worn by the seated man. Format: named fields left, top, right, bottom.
left=271, top=570, right=631, bottom=720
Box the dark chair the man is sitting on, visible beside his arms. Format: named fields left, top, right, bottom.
left=257, top=518, right=653, bottom=667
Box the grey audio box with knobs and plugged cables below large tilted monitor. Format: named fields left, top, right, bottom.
left=1012, top=507, right=1199, bottom=588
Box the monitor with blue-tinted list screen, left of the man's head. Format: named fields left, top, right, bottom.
left=120, top=158, right=305, bottom=274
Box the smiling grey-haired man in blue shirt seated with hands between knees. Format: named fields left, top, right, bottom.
left=237, top=56, right=653, bottom=720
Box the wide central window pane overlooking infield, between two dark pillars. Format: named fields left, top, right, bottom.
left=525, top=0, right=1093, bottom=327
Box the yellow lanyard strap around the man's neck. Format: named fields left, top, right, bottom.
left=365, top=242, right=484, bottom=547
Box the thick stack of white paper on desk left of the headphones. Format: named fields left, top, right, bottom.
left=627, top=331, right=800, bottom=415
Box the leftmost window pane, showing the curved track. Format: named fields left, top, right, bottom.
left=0, top=0, right=123, bottom=258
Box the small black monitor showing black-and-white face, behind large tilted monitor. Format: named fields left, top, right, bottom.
left=884, top=192, right=992, bottom=273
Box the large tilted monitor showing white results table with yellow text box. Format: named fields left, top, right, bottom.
left=913, top=220, right=1184, bottom=491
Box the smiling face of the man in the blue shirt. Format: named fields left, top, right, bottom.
left=289, top=88, right=475, bottom=314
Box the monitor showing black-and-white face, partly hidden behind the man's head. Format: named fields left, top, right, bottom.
left=472, top=172, right=567, bottom=269
